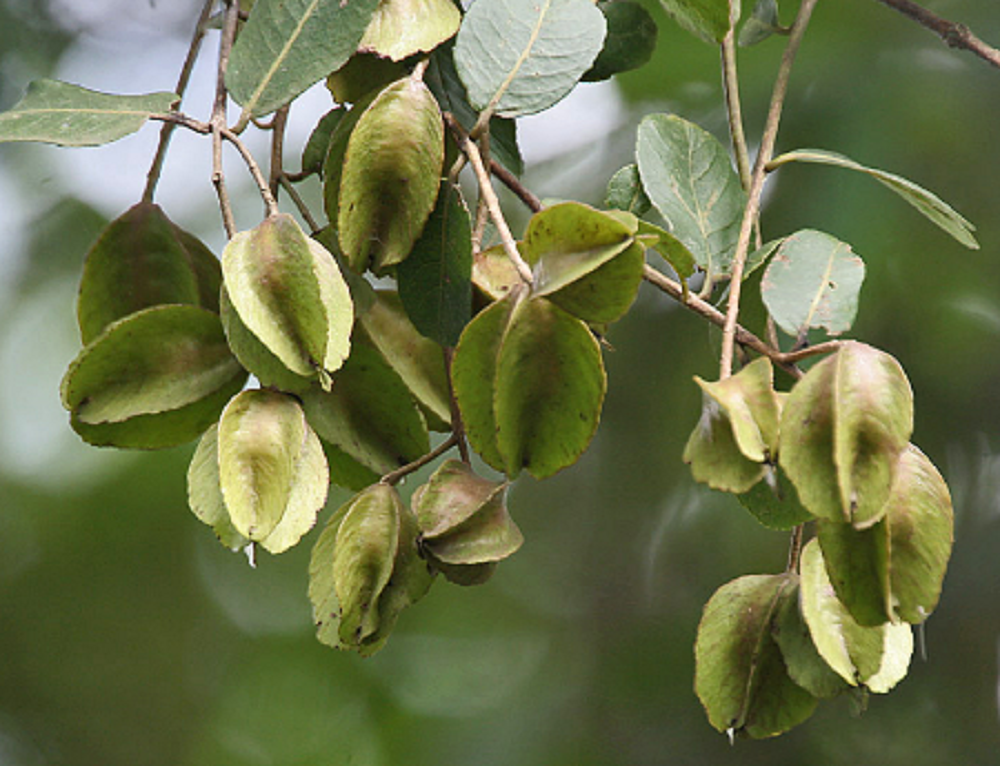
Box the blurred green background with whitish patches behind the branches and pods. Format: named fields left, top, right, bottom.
left=0, top=0, right=1000, bottom=766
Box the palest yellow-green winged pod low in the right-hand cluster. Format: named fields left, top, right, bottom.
left=801, top=540, right=913, bottom=693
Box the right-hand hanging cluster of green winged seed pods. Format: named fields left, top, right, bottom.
left=684, top=342, right=953, bottom=737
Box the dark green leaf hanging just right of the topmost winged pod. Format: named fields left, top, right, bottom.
left=396, top=180, right=472, bottom=347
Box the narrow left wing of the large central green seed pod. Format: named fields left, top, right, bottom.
left=451, top=296, right=515, bottom=471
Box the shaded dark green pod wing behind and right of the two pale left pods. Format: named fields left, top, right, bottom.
left=302, top=343, right=430, bottom=475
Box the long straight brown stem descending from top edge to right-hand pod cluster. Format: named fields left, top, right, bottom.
left=719, top=0, right=817, bottom=379
